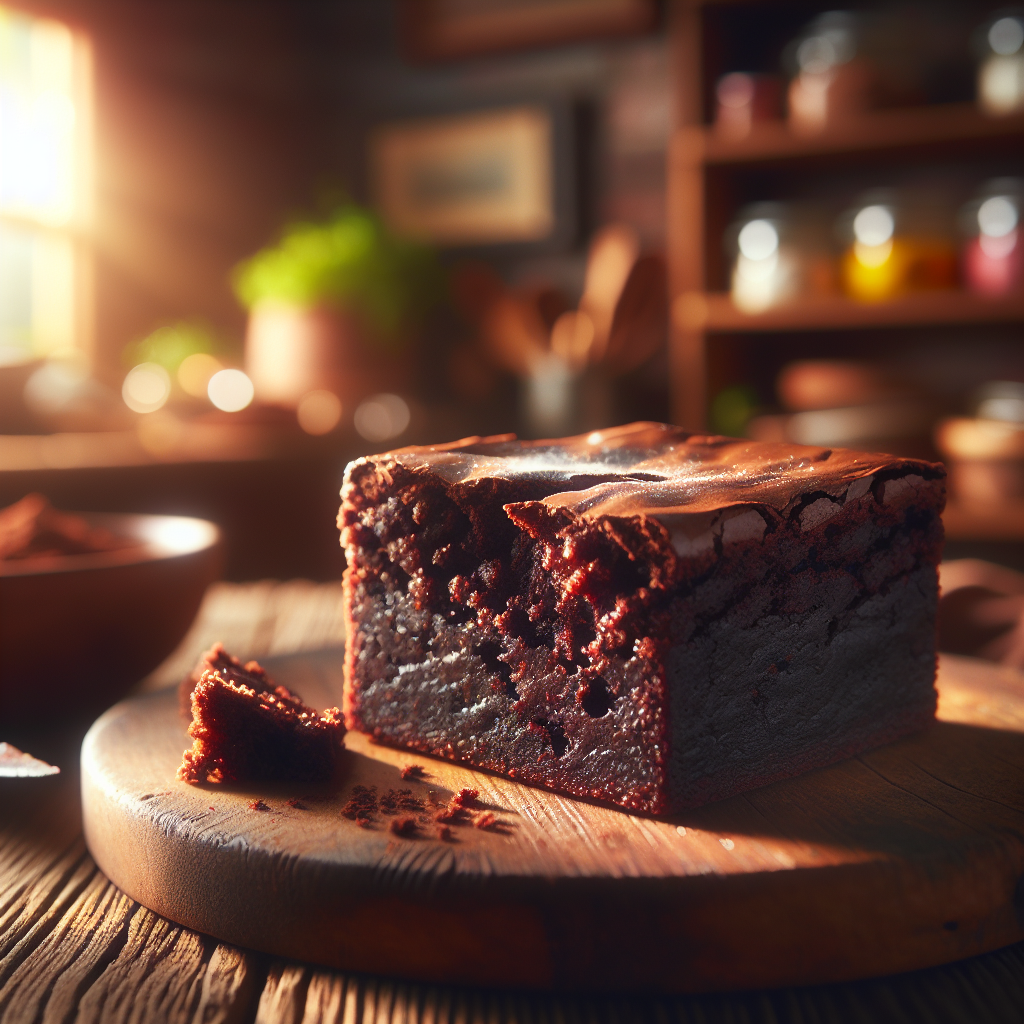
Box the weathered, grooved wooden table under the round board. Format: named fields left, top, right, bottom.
left=0, top=583, right=1024, bottom=1024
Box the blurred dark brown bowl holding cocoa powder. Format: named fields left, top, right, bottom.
left=0, top=512, right=223, bottom=723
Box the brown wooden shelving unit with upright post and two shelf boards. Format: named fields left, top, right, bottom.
left=667, top=6, right=1024, bottom=430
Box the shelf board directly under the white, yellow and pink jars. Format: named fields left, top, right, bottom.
left=676, top=291, right=1024, bottom=334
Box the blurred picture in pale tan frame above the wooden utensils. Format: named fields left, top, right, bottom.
left=370, top=103, right=573, bottom=248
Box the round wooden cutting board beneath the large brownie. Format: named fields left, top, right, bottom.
left=82, top=651, right=1024, bottom=991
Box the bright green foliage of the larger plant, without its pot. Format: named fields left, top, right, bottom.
left=233, top=205, right=443, bottom=342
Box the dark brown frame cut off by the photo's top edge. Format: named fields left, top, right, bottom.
left=400, top=0, right=657, bottom=60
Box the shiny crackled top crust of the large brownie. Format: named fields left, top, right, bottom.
left=358, top=423, right=944, bottom=518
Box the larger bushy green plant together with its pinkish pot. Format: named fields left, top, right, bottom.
left=233, top=205, right=441, bottom=410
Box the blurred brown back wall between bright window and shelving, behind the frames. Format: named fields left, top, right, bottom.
left=8, top=0, right=669, bottom=384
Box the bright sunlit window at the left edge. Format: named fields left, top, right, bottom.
left=0, top=7, right=90, bottom=364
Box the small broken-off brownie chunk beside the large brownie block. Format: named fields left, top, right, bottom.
left=177, top=644, right=345, bottom=782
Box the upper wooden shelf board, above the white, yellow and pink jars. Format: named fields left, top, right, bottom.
left=676, top=103, right=1024, bottom=167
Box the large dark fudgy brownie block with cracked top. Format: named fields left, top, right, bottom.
left=339, top=423, right=944, bottom=813
